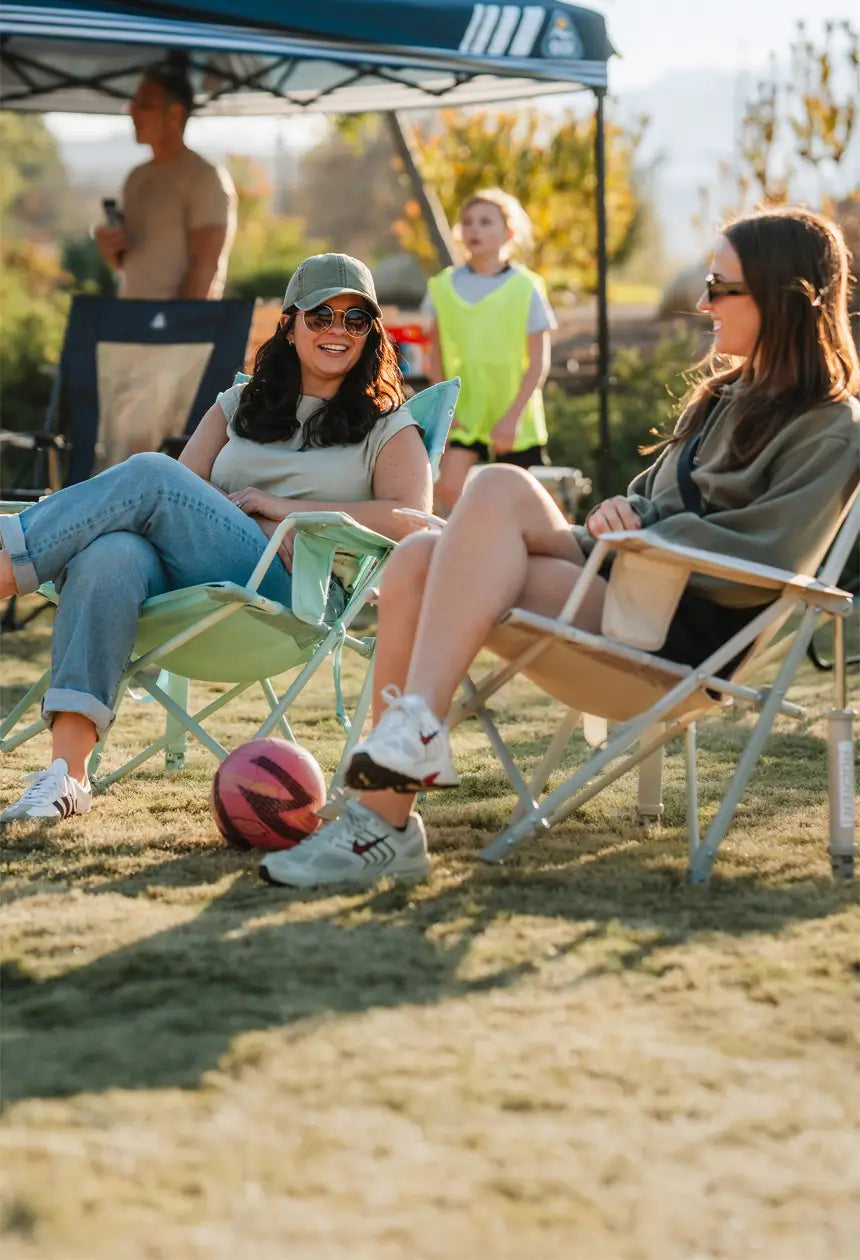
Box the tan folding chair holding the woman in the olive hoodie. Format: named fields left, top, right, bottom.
left=448, top=490, right=860, bottom=883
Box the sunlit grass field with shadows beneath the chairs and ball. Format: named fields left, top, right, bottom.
left=0, top=602, right=860, bottom=1260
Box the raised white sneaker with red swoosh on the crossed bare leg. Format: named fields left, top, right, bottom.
left=346, top=687, right=460, bottom=793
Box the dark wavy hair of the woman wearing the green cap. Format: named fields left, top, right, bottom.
left=233, top=307, right=405, bottom=451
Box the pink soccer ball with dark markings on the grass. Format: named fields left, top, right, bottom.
left=209, top=738, right=326, bottom=849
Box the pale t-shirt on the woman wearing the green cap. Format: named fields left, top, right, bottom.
left=209, top=384, right=417, bottom=503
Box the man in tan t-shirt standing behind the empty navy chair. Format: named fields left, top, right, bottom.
left=94, top=66, right=235, bottom=301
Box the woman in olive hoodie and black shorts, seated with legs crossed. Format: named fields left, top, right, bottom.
left=261, top=207, right=860, bottom=887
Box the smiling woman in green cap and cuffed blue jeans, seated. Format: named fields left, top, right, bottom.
left=0, top=253, right=432, bottom=822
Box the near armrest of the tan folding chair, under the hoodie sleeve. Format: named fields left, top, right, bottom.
left=599, top=529, right=851, bottom=615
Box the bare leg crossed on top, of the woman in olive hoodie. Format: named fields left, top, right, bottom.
left=403, top=464, right=606, bottom=718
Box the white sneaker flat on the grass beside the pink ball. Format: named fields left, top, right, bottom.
left=259, top=800, right=429, bottom=888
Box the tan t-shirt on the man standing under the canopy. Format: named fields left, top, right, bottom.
left=120, top=149, right=235, bottom=301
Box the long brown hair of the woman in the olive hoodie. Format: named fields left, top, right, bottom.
left=651, top=205, right=860, bottom=467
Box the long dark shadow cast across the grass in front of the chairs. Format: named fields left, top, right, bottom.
left=4, top=811, right=852, bottom=1103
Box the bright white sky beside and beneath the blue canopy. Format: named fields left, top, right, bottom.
left=49, top=0, right=856, bottom=149
